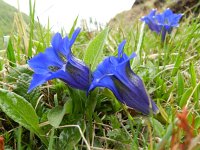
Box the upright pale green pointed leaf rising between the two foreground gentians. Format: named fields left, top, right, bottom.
left=84, top=28, right=109, bottom=71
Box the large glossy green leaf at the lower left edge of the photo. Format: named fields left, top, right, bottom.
left=0, top=89, right=48, bottom=145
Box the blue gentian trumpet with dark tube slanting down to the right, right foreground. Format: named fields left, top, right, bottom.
left=89, top=41, right=158, bottom=115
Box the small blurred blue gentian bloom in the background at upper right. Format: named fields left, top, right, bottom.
left=141, top=8, right=183, bottom=41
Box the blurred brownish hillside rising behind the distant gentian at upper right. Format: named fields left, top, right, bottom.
left=108, top=0, right=200, bottom=28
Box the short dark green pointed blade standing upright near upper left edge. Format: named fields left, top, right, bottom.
left=7, top=39, right=16, bottom=67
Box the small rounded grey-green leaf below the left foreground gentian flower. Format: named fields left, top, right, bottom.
left=47, top=103, right=67, bottom=128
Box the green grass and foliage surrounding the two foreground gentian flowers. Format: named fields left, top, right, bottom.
left=0, top=3, right=200, bottom=150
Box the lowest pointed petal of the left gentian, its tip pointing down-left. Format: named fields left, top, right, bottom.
left=28, top=73, right=51, bottom=93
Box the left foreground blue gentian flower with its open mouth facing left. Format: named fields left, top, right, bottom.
left=28, top=28, right=90, bottom=92
